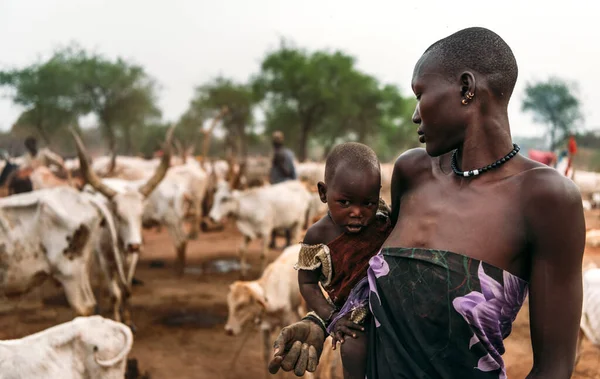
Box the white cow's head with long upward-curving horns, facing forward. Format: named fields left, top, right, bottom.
left=72, top=125, right=175, bottom=252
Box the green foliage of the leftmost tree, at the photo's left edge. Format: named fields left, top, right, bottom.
left=0, top=45, right=160, bottom=153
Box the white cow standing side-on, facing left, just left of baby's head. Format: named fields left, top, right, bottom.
left=209, top=180, right=312, bottom=276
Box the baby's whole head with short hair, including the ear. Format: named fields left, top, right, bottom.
left=317, top=142, right=381, bottom=233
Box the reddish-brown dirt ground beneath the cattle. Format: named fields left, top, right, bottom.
left=0, top=212, right=600, bottom=379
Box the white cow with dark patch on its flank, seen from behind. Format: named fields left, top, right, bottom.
left=0, top=187, right=125, bottom=315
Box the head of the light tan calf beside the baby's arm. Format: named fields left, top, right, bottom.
left=225, top=281, right=267, bottom=336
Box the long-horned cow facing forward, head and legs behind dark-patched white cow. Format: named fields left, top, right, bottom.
left=72, top=127, right=174, bottom=327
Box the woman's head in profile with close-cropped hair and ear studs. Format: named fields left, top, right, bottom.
left=412, top=28, right=518, bottom=156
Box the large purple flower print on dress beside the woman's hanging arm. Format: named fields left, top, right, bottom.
left=452, top=263, right=528, bottom=379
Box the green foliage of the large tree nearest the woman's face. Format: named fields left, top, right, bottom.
left=253, top=41, right=416, bottom=161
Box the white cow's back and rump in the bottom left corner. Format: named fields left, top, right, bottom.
left=0, top=316, right=133, bottom=379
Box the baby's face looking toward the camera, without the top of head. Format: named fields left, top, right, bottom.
left=326, top=169, right=381, bottom=234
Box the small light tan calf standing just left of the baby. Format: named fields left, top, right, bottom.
left=225, top=244, right=306, bottom=372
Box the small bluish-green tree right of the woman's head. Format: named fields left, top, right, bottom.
left=521, top=78, right=583, bottom=150
